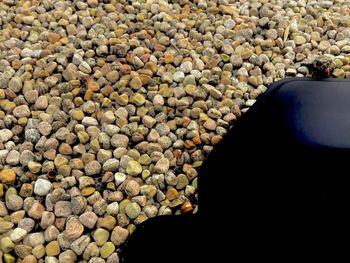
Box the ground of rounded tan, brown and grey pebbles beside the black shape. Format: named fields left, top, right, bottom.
left=0, top=0, right=350, bottom=263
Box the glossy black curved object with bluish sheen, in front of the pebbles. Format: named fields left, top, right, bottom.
left=122, top=78, right=350, bottom=263
